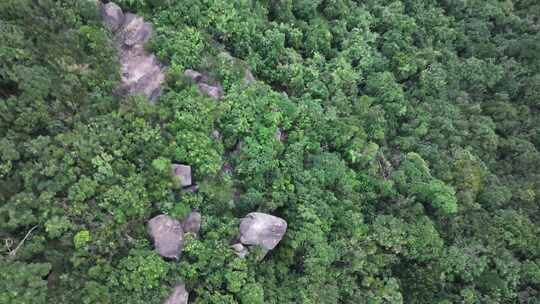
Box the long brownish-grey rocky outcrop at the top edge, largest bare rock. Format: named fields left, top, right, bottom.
left=101, top=2, right=165, bottom=101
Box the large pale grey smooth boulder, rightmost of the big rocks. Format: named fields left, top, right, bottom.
left=240, top=212, right=287, bottom=250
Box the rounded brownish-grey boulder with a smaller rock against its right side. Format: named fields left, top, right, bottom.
left=148, top=214, right=184, bottom=259
